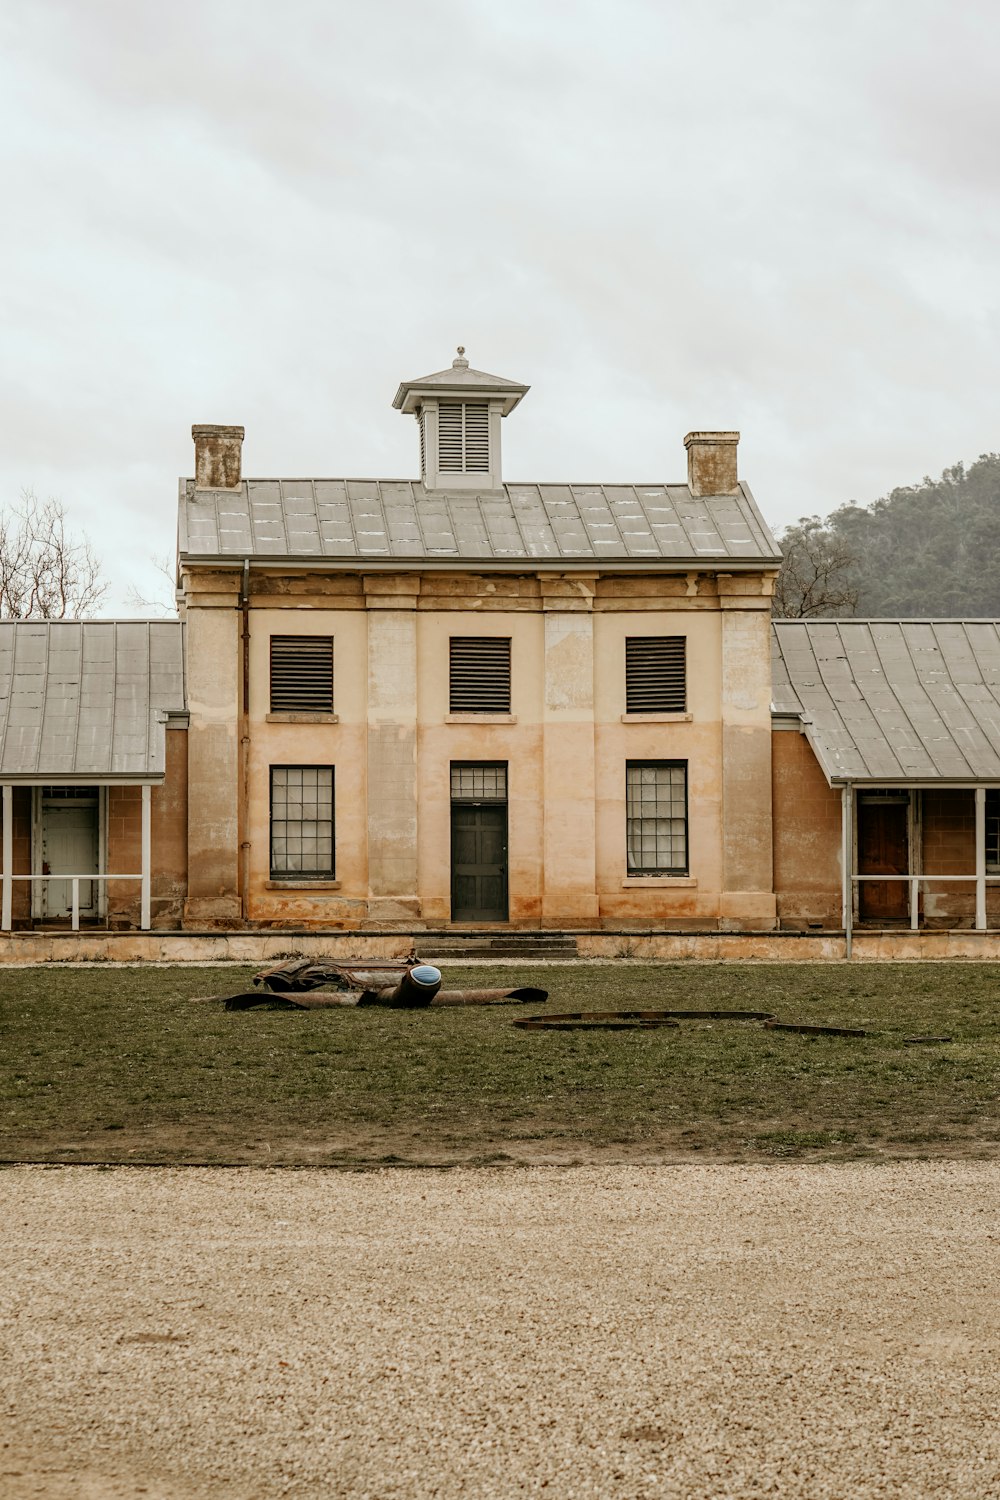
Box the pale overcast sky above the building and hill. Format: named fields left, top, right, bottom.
left=0, top=0, right=1000, bottom=614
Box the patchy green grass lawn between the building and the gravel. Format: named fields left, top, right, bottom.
left=0, top=963, right=1000, bottom=1166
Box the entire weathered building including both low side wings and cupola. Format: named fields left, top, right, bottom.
left=0, top=351, right=1000, bottom=947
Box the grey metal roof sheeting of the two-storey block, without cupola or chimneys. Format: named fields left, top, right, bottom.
left=180, top=479, right=781, bottom=569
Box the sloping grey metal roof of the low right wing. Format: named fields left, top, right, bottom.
left=772, top=620, right=1000, bottom=785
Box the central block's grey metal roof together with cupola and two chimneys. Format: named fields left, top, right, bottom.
left=178, top=348, right=781, bottom=573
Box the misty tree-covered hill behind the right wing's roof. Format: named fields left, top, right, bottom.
left=777, top=453, right=1000, bottom=617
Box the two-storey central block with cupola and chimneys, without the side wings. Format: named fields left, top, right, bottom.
left=178, top=354, right=780, bottom=929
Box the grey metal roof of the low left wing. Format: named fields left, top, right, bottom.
left=0, top=620, right=184, bottom=782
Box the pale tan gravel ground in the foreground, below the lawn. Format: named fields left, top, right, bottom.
left=0, top=1163, right=1000, bottom=1500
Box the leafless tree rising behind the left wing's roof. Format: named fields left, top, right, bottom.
left=0, top=489, right=108, bottom=620
